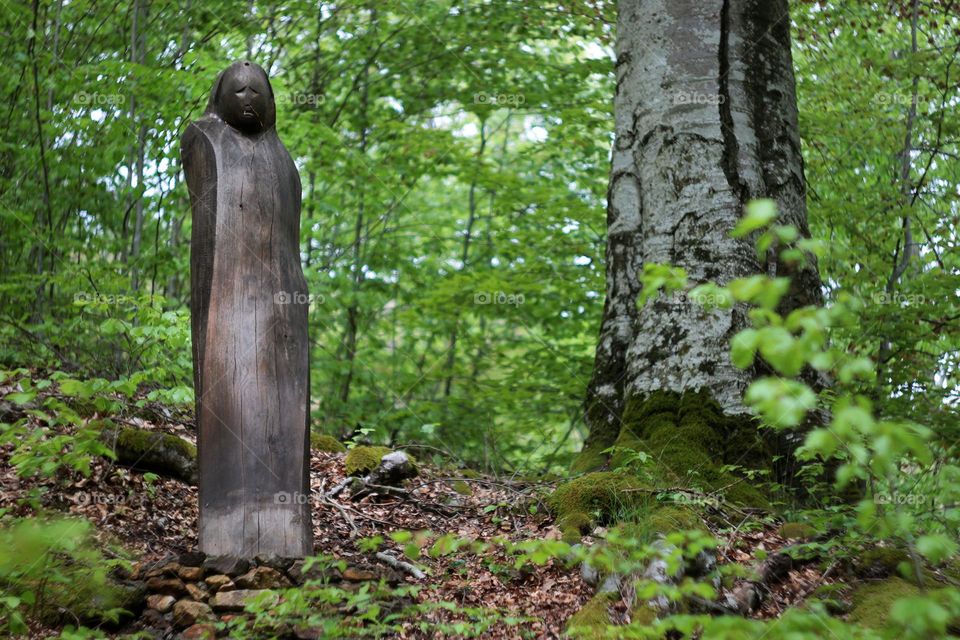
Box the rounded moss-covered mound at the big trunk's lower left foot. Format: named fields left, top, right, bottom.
left=547, top=471, right=652, bottom=542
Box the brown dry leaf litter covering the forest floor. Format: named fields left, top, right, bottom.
left=0, top=398, right=856, bottom=638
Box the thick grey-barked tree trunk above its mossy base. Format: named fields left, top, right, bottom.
left=586, top=0, right=820, bottom=462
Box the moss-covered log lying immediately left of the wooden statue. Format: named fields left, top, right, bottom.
left=101, top=427, right=197, bottom=484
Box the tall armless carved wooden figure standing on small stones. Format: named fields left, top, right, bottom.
left=181, top=61, right=313, bottom=557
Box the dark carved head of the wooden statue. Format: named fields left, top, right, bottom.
left=207, top=60, right=277, bottom=133
